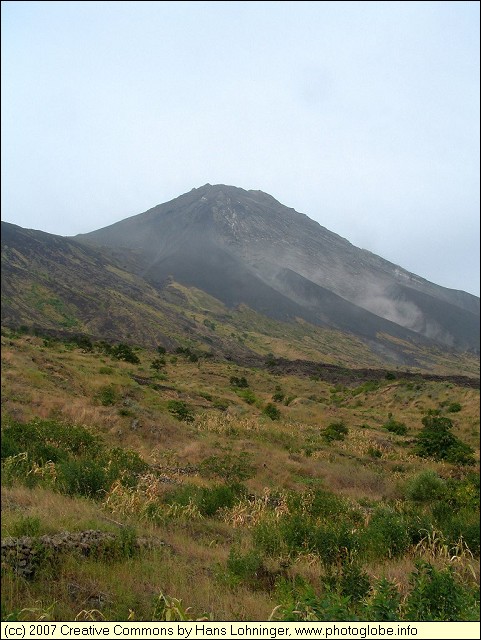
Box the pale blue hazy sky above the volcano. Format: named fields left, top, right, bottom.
left=1, top=2, right=480, bottom=295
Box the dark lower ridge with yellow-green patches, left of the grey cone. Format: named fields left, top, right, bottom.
left=2, top=222, right=250, bottom=357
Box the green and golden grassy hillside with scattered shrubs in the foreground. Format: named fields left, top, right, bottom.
left=2, top=330, right=479, bottom=620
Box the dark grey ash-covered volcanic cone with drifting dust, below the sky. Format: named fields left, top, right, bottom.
left=76, top=185, right=479, bottom=353
